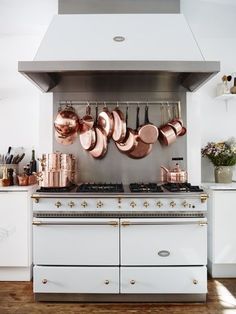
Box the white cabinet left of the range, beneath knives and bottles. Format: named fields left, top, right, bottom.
left=0, top=187, right=32, bottom=280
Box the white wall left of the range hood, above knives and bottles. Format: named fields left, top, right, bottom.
left=0, top=0, right=57, bottom=161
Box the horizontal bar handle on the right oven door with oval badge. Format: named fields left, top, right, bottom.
left=121, top=220, right=207, bottom=227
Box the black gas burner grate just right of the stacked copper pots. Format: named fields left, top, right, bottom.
left=76, top=183, right=124, bottom=193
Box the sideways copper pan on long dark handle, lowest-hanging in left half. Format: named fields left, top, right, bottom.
left=89, top=106, right=108, bottom=158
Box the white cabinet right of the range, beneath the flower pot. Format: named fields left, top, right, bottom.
left=208, top=189, right=236, bottom=277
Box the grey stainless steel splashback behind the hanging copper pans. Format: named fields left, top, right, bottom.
left=53, top=93, right=187, bottom=184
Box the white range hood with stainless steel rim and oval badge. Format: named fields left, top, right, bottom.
left=18, top=1, right=220, bottom=92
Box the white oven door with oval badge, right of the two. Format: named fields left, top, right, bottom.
left=121, top=218, right=207, bottom=266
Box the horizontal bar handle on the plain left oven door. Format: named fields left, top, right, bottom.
left=32, top=220, right=119, bottom=227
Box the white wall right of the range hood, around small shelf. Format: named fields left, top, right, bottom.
left=181, top=0, right=236, bottom=181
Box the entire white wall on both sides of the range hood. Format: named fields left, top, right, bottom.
left=0, top=0, right=236, bottom=182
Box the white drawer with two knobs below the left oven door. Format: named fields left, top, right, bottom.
left=34, top=266, right=119, bottom=293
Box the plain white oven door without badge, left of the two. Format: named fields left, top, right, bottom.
left=33, top=218, right=119, bottom=266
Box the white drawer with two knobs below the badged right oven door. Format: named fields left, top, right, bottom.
left=120, top=266, right=207, bottom=294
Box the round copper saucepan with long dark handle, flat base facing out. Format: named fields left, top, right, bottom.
left=138, top=105, right=159, bottom=144
